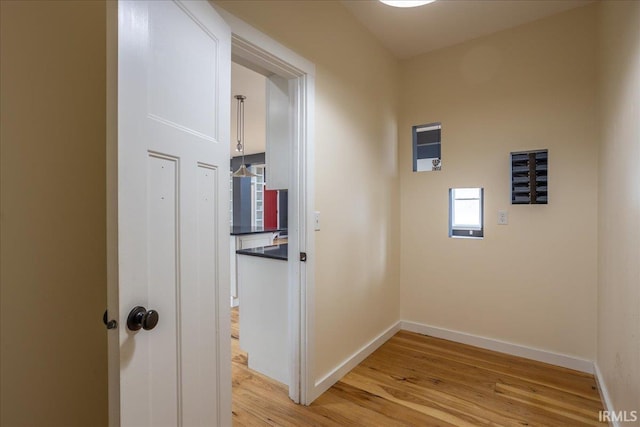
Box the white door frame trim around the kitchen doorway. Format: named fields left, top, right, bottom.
left=214, top=5, right=317, bottom=405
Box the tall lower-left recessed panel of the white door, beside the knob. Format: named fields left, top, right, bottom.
left=148, top=154, right=182, bottom=425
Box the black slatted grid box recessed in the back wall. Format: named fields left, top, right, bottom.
left=511, top=150, right=549, bottom=205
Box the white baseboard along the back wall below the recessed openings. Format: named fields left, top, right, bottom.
left=400, top=320, right=594, bottom=374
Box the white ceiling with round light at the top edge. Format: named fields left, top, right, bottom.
left=342, top=0, right=593, bottom=58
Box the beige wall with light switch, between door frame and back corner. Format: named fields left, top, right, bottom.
left=216, top=1, right=399, bottom=379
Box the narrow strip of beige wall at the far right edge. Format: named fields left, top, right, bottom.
left=597, top=1, right=640, bottom=416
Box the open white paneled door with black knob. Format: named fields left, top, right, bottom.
left=107, top=1, right=231, bottom=427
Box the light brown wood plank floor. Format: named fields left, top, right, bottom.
left=232, top=309, right=606, bottom=427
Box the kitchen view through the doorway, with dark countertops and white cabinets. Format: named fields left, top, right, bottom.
left=229, top=62, right=295, bottom=400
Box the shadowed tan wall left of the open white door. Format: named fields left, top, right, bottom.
left=0, top=1, right=107, bottom=427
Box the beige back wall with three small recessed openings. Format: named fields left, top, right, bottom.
left=399, top=6, right=598, bottom=360
